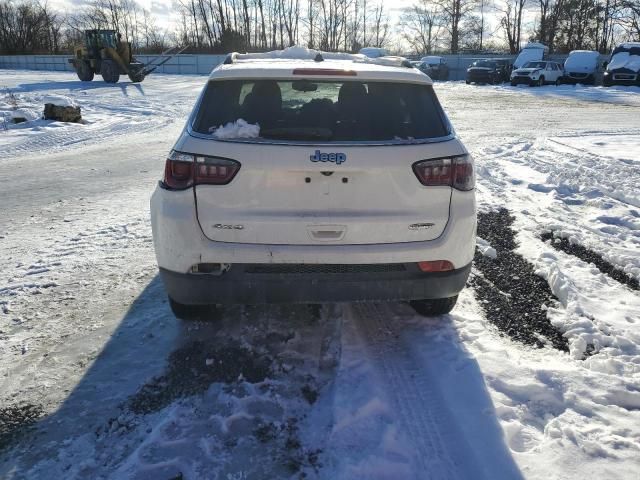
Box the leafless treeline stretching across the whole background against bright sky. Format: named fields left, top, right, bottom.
left=0, top=0, right=640, bottom=54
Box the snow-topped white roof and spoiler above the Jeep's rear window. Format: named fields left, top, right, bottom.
left=209, top=47, right=432, bottom=85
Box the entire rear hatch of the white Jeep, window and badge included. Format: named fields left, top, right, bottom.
left=181, top=79, right=458, bottom=245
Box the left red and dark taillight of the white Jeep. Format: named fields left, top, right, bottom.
left=163, top=151, right=240, bottom=190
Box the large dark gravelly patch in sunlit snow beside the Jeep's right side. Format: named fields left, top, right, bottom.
left=469, top=209, right=569, bottom=352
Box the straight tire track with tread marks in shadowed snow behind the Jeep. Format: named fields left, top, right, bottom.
left=351, top=304, right=472, bottom=480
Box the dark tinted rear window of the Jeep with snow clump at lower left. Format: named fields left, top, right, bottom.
left=192, top=80, right=450, bottom=142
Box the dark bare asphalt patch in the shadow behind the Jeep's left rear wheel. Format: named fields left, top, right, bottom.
left=127, top=341, right=271, bottom=414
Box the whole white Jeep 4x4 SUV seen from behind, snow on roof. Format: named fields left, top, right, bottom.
left=151, top=48, right=476, bottom=318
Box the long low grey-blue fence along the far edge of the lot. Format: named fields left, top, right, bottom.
left=0, top=55, right=606, bottom=80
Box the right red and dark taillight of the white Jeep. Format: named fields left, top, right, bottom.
left=413, top=155, right=476, bottom=191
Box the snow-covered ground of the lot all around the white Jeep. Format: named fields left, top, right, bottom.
left=0, top=71, right=640, bottom=480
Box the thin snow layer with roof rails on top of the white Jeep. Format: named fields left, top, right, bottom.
left=223, top=47, right=414, bottom=68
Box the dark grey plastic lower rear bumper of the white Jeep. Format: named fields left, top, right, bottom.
left=160, top=263, right=471, bottom=305
